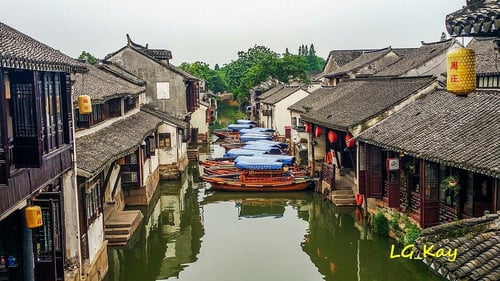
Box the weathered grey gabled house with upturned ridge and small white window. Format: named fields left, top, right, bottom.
left=105, top=35, right=206, bottom=177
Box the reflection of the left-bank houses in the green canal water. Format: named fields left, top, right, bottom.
left=106, top=172, right=204, bottom=281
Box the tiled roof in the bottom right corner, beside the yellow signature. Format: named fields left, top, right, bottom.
left=415, top=214, right=500, bottom=281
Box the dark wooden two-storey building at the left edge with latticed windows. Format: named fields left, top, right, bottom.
left=0, top=23, right=87, bottom=281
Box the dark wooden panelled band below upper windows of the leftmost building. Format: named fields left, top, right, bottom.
left=0, top=145, right=72, bottom=217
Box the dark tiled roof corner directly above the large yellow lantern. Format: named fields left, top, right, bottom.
left=445, top=0, right=500, bottom=37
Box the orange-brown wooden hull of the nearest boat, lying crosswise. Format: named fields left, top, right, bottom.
left=201, top=175, right=313, bottom=192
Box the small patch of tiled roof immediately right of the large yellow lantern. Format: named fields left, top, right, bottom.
left=467, top=38, right=500, bottom=75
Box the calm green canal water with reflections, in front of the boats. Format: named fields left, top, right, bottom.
left=105, top=142, right=443, bottom=281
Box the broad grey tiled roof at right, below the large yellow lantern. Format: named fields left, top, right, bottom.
left=358, top=87, right=500, bottom=178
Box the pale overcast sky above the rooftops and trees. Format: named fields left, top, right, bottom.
left=0, top=0, right=465, bottom=68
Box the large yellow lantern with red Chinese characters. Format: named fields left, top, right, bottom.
left=446, top=48, right=476, bottom=95
